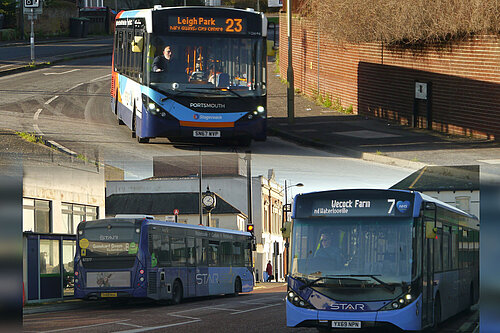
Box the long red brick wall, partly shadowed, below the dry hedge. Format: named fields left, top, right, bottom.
left=279, top=13, right=500, bottom=138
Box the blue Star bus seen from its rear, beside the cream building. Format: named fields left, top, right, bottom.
left=74, top=218, right=254, bottom=303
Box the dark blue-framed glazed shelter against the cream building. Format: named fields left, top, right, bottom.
left=23, top=232, right=76, bottom=302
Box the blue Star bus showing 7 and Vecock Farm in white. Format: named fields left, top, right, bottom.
left=286, top=189, right=479, bottom=331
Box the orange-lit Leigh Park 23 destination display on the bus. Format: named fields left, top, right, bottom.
left=168, top=15, right=247, bottom=34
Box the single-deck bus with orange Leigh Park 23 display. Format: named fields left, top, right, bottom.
left=111, top=6, right=267, bottom=145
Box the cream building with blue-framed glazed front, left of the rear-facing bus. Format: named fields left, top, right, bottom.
left=23, top=161, right=105, bottom=302
